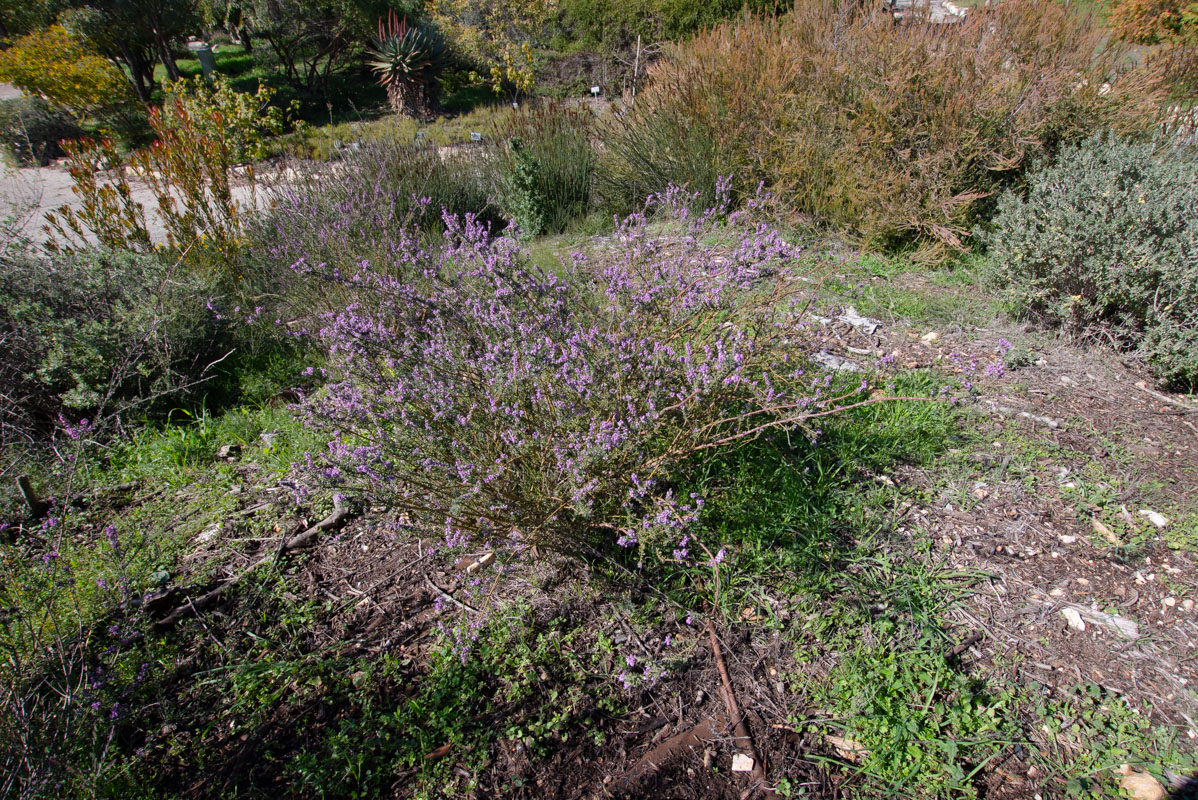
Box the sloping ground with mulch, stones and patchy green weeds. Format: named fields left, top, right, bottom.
left=2, top=242, right=1198, bottom=799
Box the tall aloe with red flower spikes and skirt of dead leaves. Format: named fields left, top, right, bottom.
left=369, top=11, right=450, bottom=117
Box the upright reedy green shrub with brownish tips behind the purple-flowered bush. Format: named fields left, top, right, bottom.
left=497, top=103, right=595, bottom=236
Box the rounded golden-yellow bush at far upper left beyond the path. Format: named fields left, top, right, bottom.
left=0, top=25, right=129, bottom=116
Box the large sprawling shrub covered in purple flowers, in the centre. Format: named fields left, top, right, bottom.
left=297, top=180, right=881, bottom=549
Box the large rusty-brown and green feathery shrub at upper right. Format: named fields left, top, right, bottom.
left=603, top=0, right=1157, bottom=259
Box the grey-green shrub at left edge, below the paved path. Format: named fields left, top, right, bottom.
left=0, top=249, right=217, bottom=440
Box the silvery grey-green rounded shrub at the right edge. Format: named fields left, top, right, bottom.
left=984, top=135, right=1198, bottom=389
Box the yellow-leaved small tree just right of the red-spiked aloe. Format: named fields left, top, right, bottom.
left=425, top=0, right=559, bottom=92
